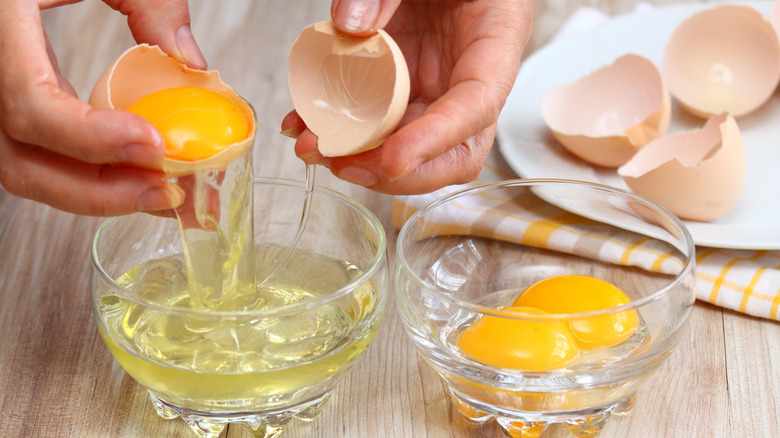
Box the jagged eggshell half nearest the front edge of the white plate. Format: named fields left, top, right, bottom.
left=618, top=113, right=745, bottom=221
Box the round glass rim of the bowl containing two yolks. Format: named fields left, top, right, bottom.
left=395, top=178, right=696, bottom=321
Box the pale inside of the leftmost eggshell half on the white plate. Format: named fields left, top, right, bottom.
left=542, top=55, right=665, bottom=137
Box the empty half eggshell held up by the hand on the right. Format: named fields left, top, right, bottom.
left=288, top=21, right=410, bottom=157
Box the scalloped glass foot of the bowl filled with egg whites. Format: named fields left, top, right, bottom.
left=149, top=391, right=332, bottom=438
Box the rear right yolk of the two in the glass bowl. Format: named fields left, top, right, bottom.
left=512, top=275, right=639, bottom=349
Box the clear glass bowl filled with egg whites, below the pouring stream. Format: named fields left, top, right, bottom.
left=91, top=178, right=389, bottom=437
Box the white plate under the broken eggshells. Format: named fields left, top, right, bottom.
left=497, top=1, right=780, bottom=249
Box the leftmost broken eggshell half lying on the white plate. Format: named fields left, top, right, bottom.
left=542, top=54, right=671, bottom=168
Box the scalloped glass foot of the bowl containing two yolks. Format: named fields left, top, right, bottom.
left=451, top=391, right=636, bottom=438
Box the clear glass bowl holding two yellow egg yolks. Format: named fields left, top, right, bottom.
left=394, top=179, right=695, bottom=437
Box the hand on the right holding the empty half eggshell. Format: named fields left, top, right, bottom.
left=282, top=0, right=532, bottom=194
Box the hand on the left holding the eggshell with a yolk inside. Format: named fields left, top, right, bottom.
left=0, top=0, right=206, bottom=216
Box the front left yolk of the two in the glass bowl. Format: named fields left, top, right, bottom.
left=457, top=307, right=579, bottom=371
